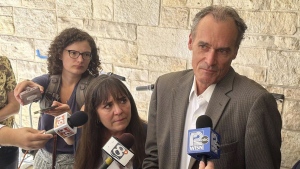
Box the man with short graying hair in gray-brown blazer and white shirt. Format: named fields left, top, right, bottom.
left=143, top=6, right=282, bottom=169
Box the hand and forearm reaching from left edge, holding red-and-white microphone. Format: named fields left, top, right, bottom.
left=0, top=127, right=53, bottom=150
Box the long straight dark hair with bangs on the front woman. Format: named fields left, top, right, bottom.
left=74, top=75, right=146, bottom=169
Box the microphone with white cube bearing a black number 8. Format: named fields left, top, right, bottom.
left=100, top=133, right=134, bottom=169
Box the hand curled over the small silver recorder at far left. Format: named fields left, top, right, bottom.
left=14, top=80, right=44, bottom=105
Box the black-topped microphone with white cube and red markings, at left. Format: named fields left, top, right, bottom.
left=45, top=111, right=88, bottom=138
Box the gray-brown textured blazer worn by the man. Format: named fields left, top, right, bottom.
left=143, top=68, right=282, bottom=169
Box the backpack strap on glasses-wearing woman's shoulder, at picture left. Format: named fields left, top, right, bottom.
left=40, top=75, right=61, bottom=109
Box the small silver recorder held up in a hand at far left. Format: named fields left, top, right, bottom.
left=20, top=86, right=42, bottom=105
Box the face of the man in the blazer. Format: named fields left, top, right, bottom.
left=188, top=14, right=238, bottom=90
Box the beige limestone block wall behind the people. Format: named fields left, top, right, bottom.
left=0, top=0, right=300, bottom=169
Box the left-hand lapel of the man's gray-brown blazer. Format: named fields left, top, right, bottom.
left=170, top=71, right=194, bottom=168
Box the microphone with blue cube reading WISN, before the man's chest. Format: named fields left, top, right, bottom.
left=187, top=115, right=221, bottom=165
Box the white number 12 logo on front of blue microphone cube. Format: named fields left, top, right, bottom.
left=189, top=131, right=209, bottom=151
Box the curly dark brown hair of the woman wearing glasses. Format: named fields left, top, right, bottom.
left=47, top=28, right=102, bottom=77
